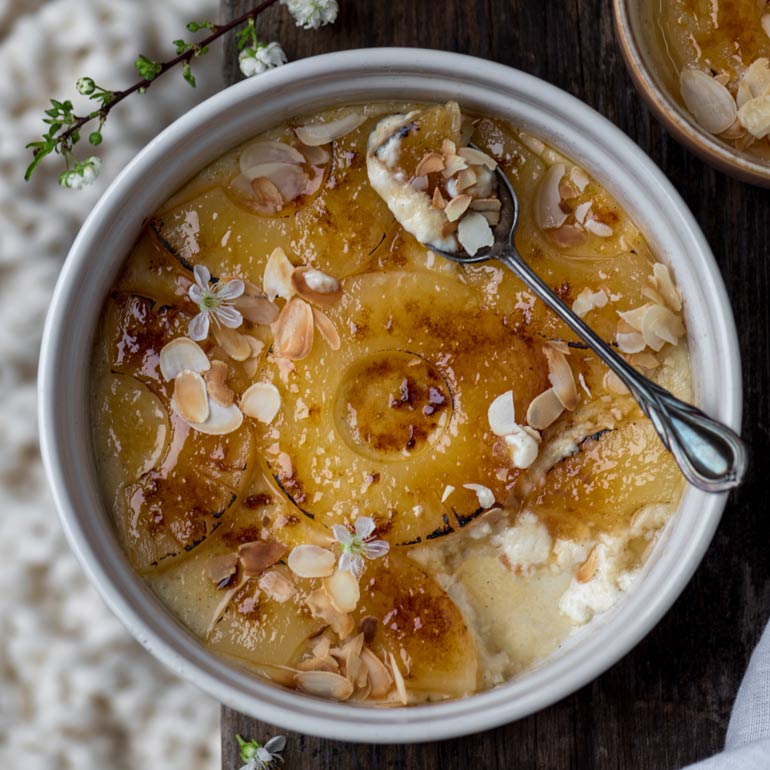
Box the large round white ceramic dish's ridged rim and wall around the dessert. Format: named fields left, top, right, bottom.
left=39, top=48, right=741, bottom=743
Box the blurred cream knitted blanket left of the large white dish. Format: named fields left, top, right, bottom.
left=0, top=0, right=226, bottom=770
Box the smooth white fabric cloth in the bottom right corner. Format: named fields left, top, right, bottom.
left=685, top=626, right=770, bottom=770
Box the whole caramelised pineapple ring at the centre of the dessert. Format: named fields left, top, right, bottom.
left=261, top=272, right=548, bottom=544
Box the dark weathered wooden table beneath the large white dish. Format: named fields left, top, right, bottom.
left=222, top=0, right=770, bottom=770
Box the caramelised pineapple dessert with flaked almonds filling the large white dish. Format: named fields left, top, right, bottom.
left=92, top=102, right=691, bottom=706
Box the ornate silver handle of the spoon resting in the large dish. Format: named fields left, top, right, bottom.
left=498, top=246, right=748, bottom=492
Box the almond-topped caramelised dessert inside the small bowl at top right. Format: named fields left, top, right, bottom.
left=649, top=0, right=770, bottom=161
